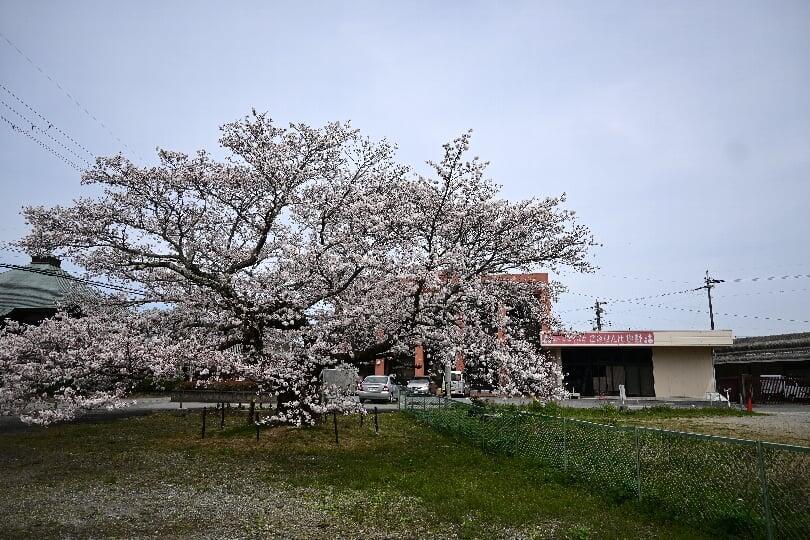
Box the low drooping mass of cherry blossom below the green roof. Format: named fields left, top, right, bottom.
left=0, top=306, right=237, bottom=425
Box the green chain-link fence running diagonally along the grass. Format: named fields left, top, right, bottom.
left=400, top=396, right=810, bottom=538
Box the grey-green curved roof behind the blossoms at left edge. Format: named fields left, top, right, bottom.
left=0, top=257, right=81, bottom=317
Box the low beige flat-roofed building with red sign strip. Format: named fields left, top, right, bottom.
left=542, top=330, right=733, bottom=399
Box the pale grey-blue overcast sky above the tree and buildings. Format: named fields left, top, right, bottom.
left=0, top=0, right=810, bottom=335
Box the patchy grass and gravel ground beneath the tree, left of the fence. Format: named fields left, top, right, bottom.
left=0, top=413, right=712, bottom=538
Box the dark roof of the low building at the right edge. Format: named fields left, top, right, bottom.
left=714, top=332, right=810, bottom=364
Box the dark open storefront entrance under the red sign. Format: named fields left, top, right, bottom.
left=561, top=347, right=655, bottom=397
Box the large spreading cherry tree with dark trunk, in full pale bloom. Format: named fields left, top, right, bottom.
left=2, top=112, right=593, bottom=424
